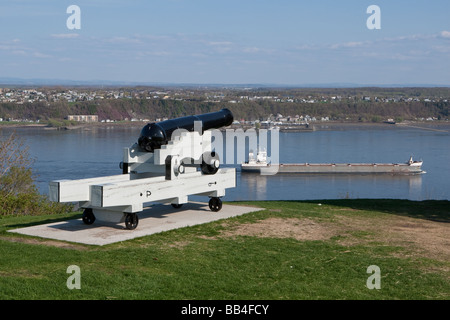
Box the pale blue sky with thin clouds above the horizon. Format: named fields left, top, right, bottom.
left=0, top=0, right=450, bottom=86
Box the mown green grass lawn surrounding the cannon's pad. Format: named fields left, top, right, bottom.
left=0, top=199, right=450, bottom=300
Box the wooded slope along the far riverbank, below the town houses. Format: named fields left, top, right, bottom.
left=0, top=91, right=450, bottom=122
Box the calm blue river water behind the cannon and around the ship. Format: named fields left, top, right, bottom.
left=0, top=124, right=450, bottom=201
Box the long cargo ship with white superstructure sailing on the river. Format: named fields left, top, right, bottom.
left=241, top=151, right=425, bottom=174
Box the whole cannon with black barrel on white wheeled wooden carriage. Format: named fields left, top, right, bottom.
left=49, top=109, right=236, bottom=230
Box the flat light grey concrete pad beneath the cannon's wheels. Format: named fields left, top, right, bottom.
left=9, top=202, right=263, bottom=246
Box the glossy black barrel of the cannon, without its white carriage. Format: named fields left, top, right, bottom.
left=138, top=109, right=233, bottom=152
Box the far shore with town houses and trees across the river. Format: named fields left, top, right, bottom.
left=0, top=87, right=450, bottom=125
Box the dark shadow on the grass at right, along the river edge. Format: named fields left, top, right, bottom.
left=300, top=199, right=450, bottom=223
